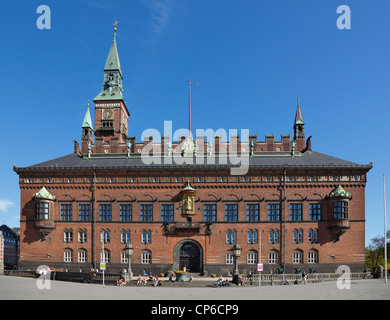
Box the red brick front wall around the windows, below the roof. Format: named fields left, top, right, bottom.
left=16, top=172, right=365, bottom=273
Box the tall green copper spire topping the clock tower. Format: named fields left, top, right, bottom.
left=94, top=28, right=123, bottom=101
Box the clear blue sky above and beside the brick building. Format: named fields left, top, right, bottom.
left=0, top=0, right=390, bottom=242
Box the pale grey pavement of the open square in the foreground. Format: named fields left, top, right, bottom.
left=0, top=276, right=390, bottom=300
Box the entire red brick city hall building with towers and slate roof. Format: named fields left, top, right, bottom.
left=14, top=33, right=372, bottom=275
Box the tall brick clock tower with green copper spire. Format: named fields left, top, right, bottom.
left=88, top=28, right=130, bottom=153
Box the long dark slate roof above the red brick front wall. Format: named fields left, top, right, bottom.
left=14, top=150, right=372, bottom=172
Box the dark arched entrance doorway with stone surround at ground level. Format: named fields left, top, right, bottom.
left=173, top=239, right=203, bottom=273
